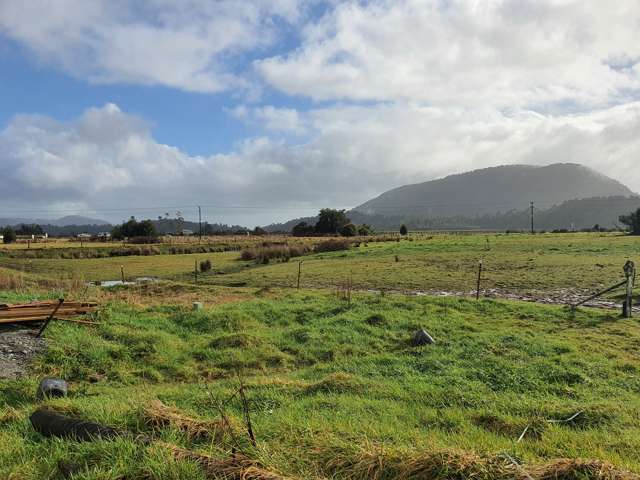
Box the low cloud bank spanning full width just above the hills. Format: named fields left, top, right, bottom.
left=0, top=102, right=640, bottom=225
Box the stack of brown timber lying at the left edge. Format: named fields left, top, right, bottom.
left=0, top=300, right=98, bottom=324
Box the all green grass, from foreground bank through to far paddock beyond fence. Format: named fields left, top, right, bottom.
left=0, top=234, right=640, bottom=480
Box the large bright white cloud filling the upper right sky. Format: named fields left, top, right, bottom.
left=256, top=0, right=640, bottom=108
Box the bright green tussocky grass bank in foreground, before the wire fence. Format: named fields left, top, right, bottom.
left=0, top=290, right=640, bottom=479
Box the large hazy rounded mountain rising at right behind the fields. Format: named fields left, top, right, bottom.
left=354, top=163, right=634, bottom=218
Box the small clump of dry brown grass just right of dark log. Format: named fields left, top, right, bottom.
left=143, top=400, right=235, bottom=442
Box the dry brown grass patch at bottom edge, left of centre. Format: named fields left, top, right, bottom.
left=166, top=445, right=292, bottom=480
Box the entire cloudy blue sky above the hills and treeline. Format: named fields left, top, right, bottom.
left=0, top=0, right=640, bottom=226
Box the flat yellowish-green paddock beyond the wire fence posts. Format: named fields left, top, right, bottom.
left=0, top=234, right=640, bottom=293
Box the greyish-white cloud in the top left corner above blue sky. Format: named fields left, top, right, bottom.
left=0, top=0, right=306, bottom=92
